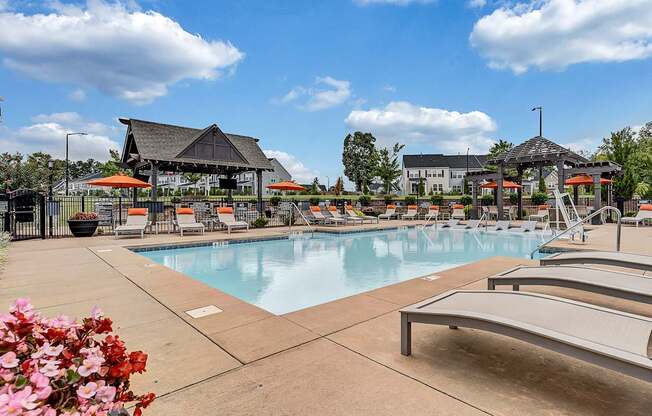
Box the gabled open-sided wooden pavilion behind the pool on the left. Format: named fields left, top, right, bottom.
left=120, top=119, right=274, bottom=211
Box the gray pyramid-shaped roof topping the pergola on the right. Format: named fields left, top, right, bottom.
left=489, top=136, right=586, bottom=164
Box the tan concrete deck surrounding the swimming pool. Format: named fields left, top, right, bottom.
left=0, top=221, right=652, bottom=415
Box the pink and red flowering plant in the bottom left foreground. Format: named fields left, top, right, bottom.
left=0, top=299, right=155, bottom=416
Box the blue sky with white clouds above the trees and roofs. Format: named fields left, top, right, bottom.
left=0, top=0, right=652, bottom=183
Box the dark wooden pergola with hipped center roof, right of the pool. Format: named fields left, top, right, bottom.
left=465, top=136, right=621, bottom=219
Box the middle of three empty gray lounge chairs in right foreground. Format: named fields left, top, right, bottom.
left=487, top=266, right=652, bottom=303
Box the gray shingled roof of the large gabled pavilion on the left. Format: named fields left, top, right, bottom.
left=120, top=118, right=272, bottom=170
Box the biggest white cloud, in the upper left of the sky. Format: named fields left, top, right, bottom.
left=0, top=0, right=244, bottom=104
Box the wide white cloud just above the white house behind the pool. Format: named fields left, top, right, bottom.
left=345, top=101, right=496, bottom=153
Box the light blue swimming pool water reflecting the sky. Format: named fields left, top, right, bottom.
left=139, top=227, right=541, bottom=314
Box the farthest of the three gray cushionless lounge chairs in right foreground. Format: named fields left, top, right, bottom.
left=539, top=251, right=652, bottom=271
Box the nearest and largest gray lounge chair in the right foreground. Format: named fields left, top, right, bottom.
left=400, top=290, right=652, bottom=382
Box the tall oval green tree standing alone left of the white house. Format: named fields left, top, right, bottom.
left=342, top=131, right=378, bottom=191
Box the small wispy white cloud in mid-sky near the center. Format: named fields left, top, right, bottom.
left=277, top=77, right=351, bottom=111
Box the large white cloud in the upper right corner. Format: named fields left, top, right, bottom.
left=470, top=0, right=652, bottom=74
